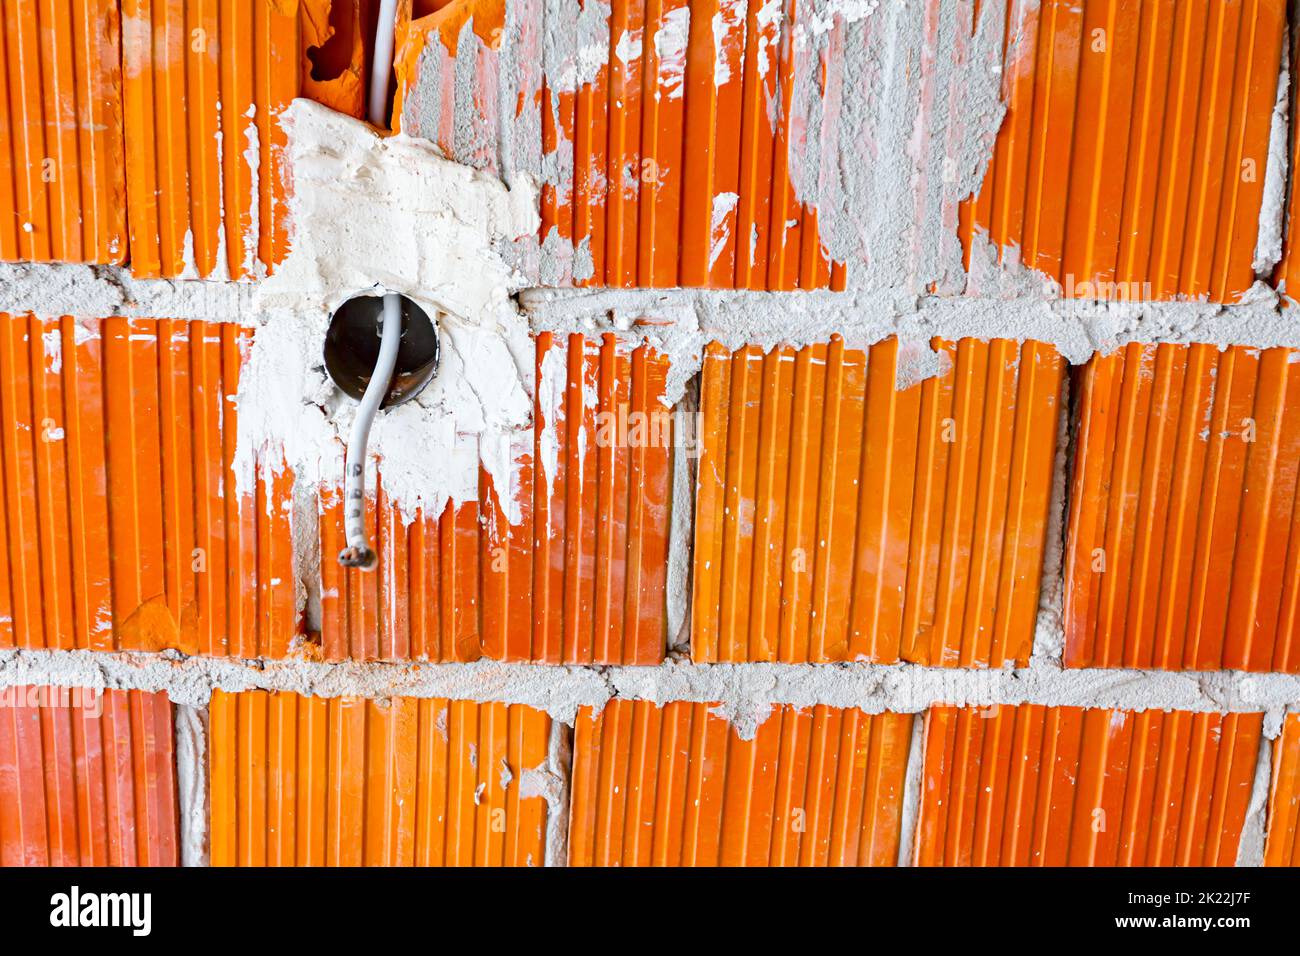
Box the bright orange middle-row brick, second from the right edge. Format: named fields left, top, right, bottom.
left=692, top=338, right=1063, bottom=667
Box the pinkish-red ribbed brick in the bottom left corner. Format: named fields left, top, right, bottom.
left=0, top=687, right=179, bottom=866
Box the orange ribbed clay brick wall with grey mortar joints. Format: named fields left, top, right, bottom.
left=0, top=0, right=1300, bottom=866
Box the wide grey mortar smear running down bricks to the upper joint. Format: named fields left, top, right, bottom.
left=784, top=0, right=1017, bottom=291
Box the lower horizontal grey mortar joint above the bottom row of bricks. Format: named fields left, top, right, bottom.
left=0, top=649, right=1300, bottom=730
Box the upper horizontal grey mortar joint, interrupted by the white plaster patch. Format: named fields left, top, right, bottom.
left=0, top=263, right=1300, bottom=363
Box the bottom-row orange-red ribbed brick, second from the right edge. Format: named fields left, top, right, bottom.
left=915, top=704, right=1264, bottom=866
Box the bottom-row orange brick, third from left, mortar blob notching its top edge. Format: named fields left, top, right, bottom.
left=569, top=700, right=913, bottom=866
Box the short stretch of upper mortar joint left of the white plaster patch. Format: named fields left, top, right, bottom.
left=0, top=263, right=255, bottom=323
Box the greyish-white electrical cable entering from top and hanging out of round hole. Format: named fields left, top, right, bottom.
left=338, top=0, right=402, bottom=571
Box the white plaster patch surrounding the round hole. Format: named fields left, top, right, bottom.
left=235, top=99, right=538, bottom=522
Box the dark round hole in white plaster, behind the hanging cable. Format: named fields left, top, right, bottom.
left=325, top=294, right=438, bottom=408
